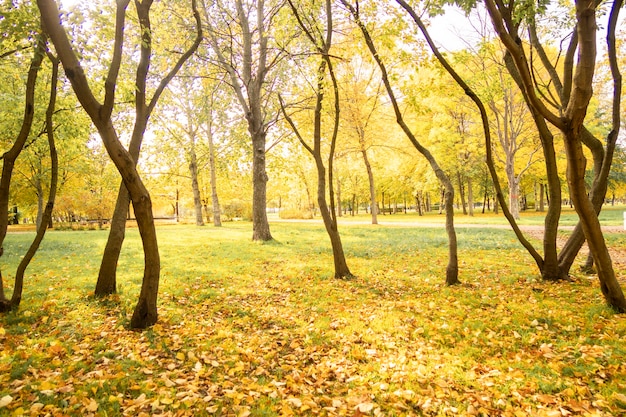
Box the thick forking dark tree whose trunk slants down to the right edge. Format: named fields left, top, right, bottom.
left=485, top=0, right=626, bottom=312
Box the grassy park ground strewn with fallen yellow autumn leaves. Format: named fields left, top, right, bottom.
left=0, top=225, right=626, bottom=416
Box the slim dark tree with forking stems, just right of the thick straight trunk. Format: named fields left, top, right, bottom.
left=281, top=0, right=352, bottom=279
